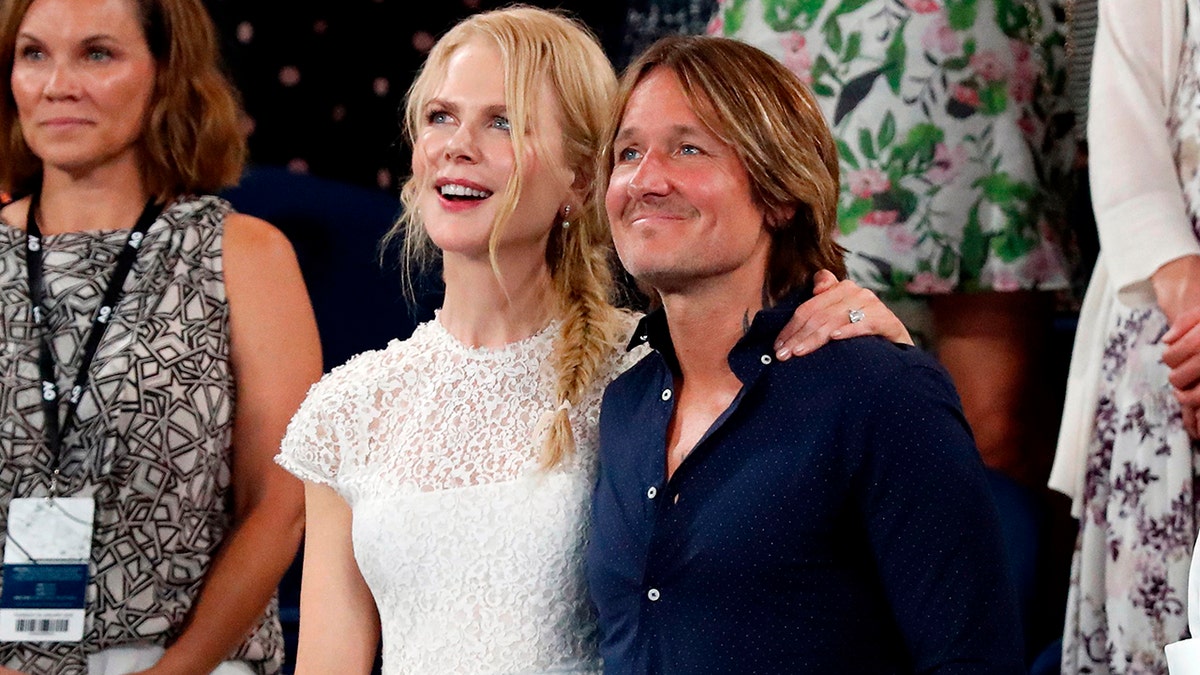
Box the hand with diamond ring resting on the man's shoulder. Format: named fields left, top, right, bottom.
left=775, top=269, right=912, bottom=360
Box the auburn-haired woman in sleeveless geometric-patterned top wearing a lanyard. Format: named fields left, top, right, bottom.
left=0, top=0, right=320, bottom=675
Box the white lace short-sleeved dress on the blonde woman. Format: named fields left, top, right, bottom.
left=277, top=319, right=644, bottom=675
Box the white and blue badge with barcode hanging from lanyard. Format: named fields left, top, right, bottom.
left=0, top=497, right=96, bottom=643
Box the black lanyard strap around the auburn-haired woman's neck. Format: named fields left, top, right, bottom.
left=25, top=192, right=162, bottom=495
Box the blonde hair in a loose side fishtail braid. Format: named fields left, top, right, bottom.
left=392, top=7, right=622, bottom=468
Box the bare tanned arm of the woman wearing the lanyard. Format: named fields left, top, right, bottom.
left=138, top=215, right=320, bottom=675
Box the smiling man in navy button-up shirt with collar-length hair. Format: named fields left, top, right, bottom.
left=588, top=37, right=1022, bottom=675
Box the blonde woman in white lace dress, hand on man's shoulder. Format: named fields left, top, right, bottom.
left=280, top=8, right=905, bottom=673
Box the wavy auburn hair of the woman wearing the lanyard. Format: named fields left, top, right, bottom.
left=0, top=0, right=246, bottom=202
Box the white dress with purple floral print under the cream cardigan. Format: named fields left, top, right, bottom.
left=1062, top=0, right=1200, bottom=674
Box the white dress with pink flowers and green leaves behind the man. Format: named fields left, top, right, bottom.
left=708, top=0, right=1074, bottom=298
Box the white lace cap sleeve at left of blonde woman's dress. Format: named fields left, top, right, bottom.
left=275, top=352, right=382, bottom=491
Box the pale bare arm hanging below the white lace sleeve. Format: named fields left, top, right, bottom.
left=296, top=482, right=379, bottom=675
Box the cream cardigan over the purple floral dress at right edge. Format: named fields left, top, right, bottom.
left=1050, top=0, right=1200, bottom=506
